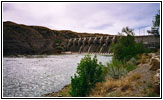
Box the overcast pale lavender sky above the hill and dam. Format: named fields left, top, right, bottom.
left=3, top=2, right=160, bottom=35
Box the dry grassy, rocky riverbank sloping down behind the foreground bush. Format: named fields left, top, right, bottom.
left=44, top=51, right=160, bottom=97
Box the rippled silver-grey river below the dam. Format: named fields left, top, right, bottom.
left=3, top=54, right=112, bottom=97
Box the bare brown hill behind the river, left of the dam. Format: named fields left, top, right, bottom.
left=3, top=21, right=109, bottom=56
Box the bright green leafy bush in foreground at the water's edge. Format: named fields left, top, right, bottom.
left=70, top=55, right=103, bottom=97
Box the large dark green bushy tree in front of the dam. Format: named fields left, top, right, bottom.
left=110, top=27, right=149, bottom=61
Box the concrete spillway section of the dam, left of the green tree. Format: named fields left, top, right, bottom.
left=67, top=36, right=116, bottom=53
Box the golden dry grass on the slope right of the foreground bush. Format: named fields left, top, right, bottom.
left=89, top=69, right=158, bottom=97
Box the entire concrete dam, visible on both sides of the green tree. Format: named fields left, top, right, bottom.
left=67, top=35, right=159, bottom=53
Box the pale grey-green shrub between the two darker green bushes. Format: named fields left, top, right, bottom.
left=106, top=59, right=127, bottom=79
